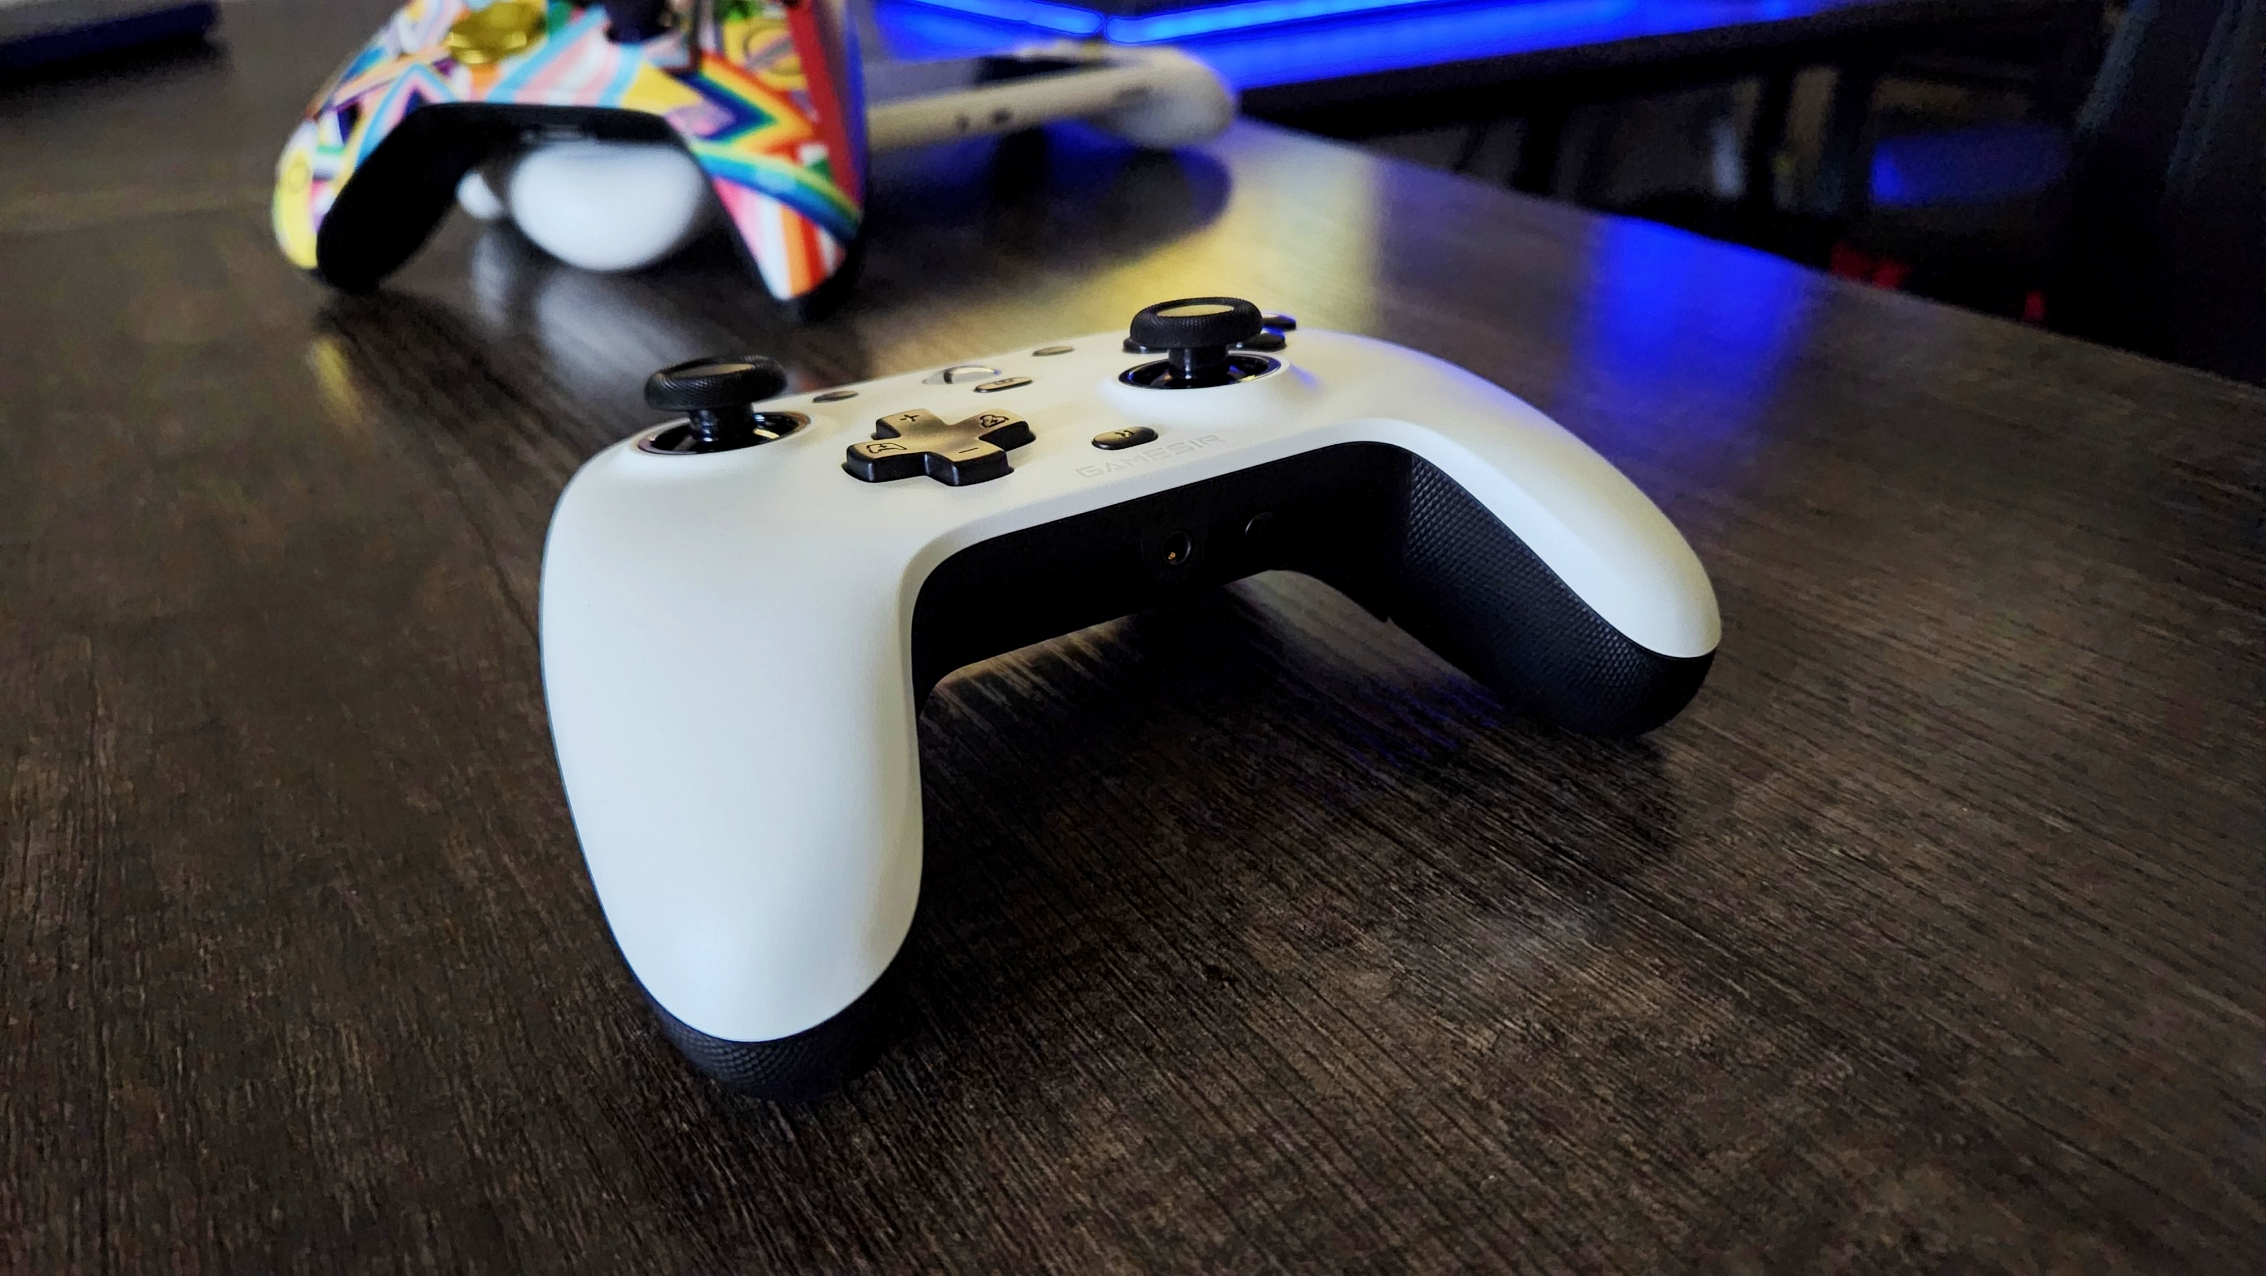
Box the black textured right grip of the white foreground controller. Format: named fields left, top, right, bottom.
left=1394, top=458, right=1715, bottom=734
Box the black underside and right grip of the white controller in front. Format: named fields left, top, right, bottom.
left=913, top=444, right=1713, bottom=734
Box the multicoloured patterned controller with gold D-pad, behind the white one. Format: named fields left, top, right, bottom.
left=274, top=0, right=866, bottom=306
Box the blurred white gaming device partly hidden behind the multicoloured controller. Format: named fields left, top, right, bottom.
left=455, top=41, right=1235, bottom=270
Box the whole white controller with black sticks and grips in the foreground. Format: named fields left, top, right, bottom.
left=542, top=297, right=1720, bottom=1097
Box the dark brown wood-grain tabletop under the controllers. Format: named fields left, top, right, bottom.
left=0, top=0, right=2266, bottom=1274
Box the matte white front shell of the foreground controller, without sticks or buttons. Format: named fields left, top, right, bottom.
left=542, top=331, right=1720, bottom=1040
